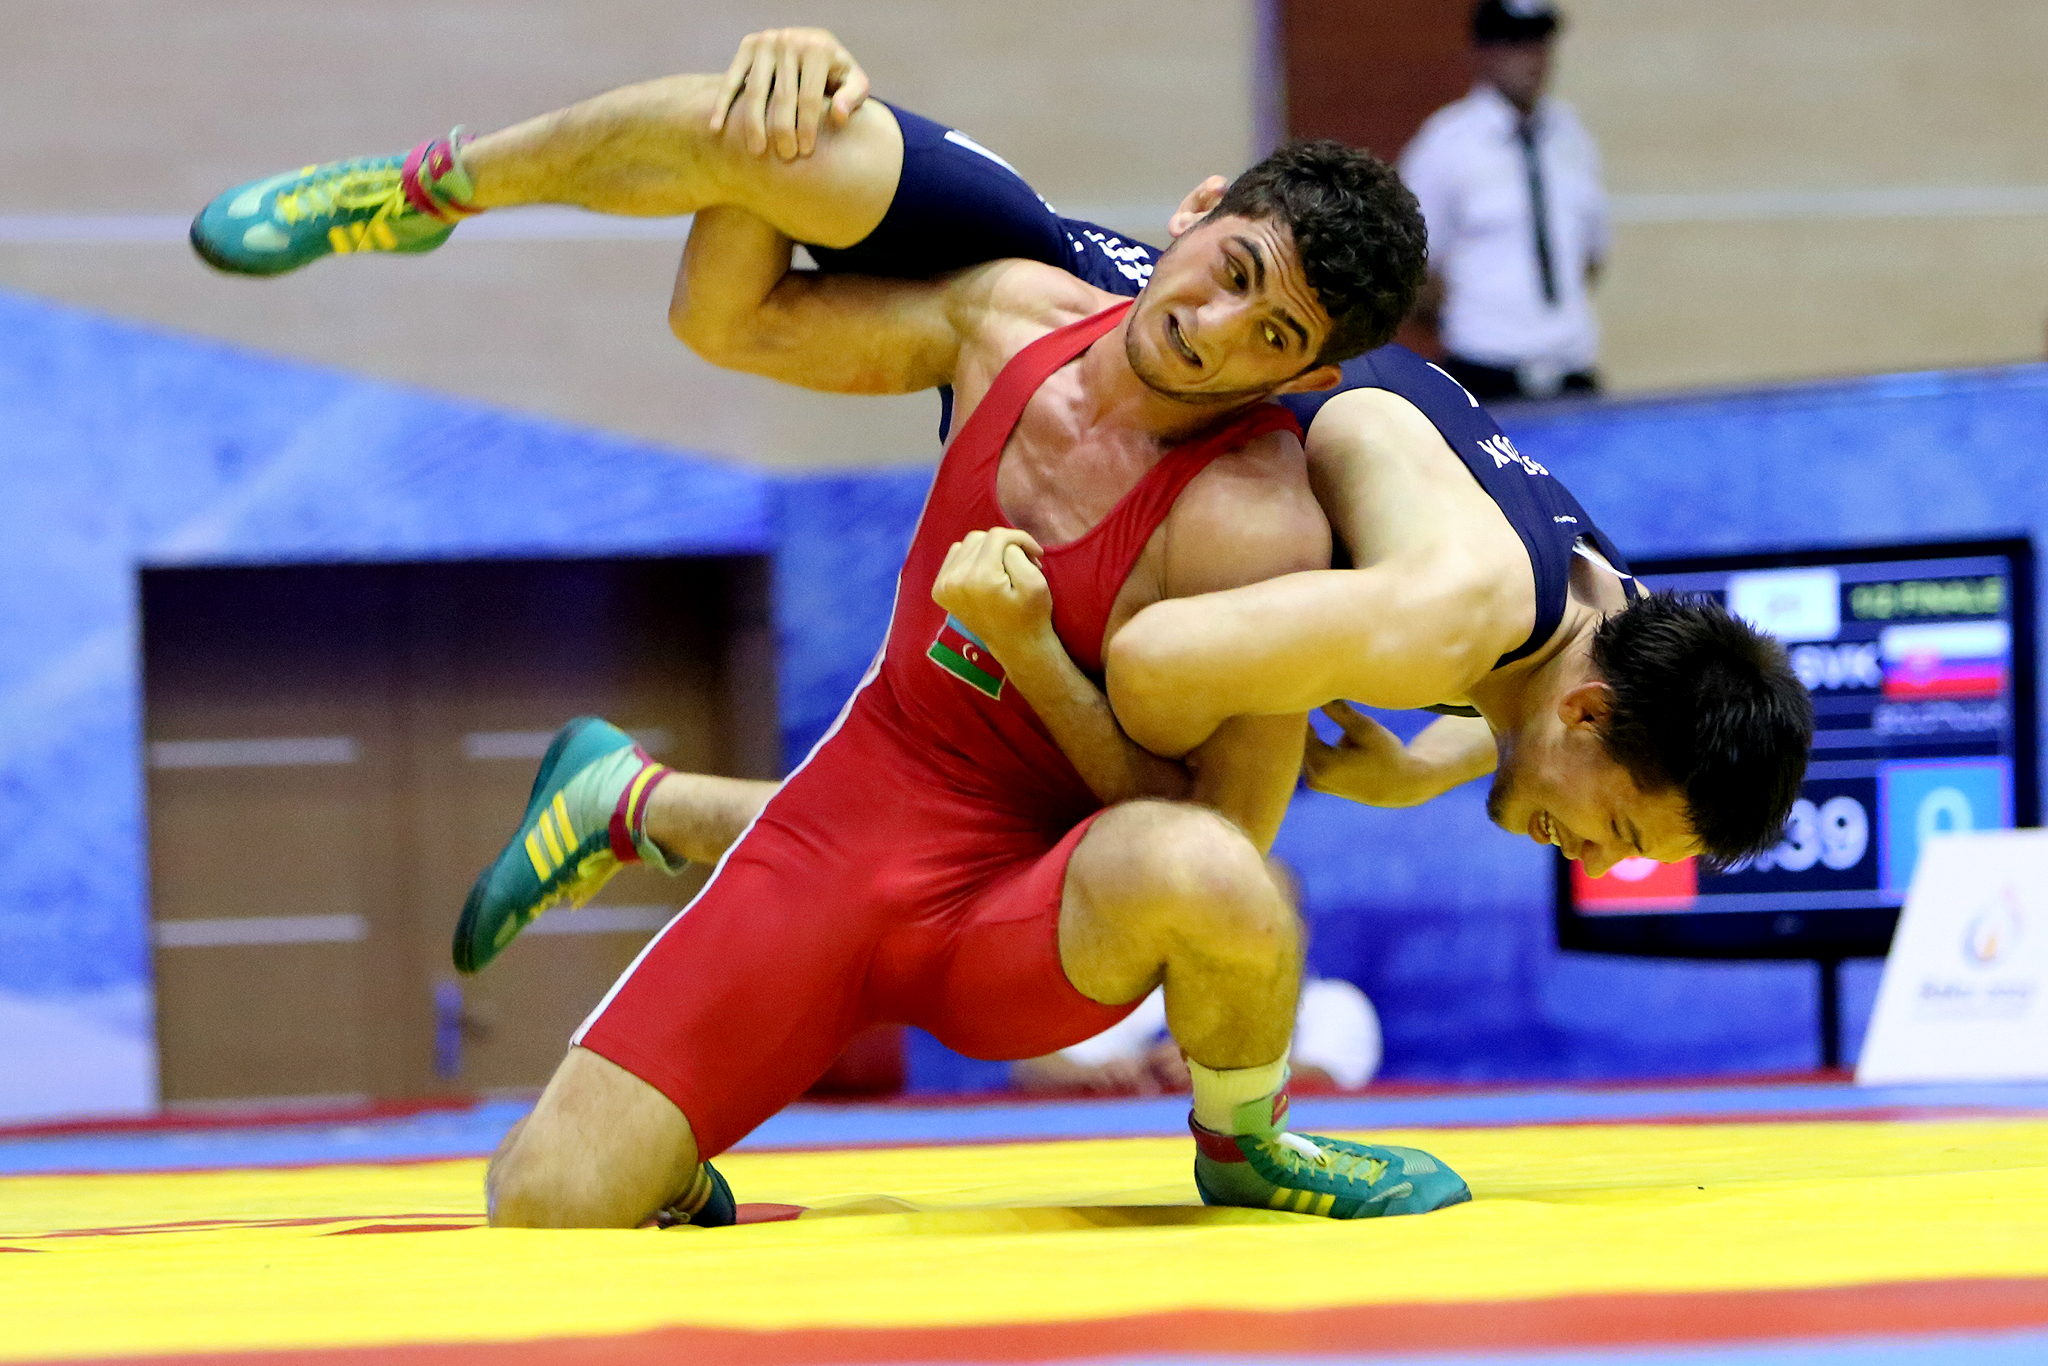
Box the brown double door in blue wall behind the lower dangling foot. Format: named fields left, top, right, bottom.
left=143, top=559, right=774, bottom=1102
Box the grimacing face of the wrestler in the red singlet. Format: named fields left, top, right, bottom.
left=1124, top=217, right=1329, bottom=403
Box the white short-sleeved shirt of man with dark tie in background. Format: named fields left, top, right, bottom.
left=1401, top=82, right=1608, bottom=385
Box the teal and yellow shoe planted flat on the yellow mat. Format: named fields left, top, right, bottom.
left=1188, top=1092, right=1473, bottom=1219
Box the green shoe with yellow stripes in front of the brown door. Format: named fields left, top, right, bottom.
left=455, top=717, right=682, bottom=973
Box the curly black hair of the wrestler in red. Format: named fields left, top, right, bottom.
left=1210, top=139, right=1430, bottom=365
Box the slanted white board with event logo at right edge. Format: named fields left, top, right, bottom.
left=1855, top=829, right=2048, bottom=1085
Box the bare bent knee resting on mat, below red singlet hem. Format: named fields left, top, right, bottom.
left=485, top=1049, right=696, bottom=1229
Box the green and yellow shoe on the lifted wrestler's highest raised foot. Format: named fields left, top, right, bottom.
left=193, top=129, right=477, bottom=274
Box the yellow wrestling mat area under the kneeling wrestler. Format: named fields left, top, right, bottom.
left=0, top=1120, right=2048, bottom=1362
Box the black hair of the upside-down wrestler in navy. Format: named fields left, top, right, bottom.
left=1593, top=592, right=1812, bottom=870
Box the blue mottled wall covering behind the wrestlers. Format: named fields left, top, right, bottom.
left=0, top=282, right=2048, bottom=1090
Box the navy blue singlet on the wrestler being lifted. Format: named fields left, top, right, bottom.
left=790, top=104, right=1640, bottom=671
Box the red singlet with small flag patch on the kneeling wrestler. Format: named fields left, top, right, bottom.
left=575, top=303, right=1300, bottom=1157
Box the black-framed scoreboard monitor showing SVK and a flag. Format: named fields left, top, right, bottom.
left=1556, top=539, right=2040, bottom=961
